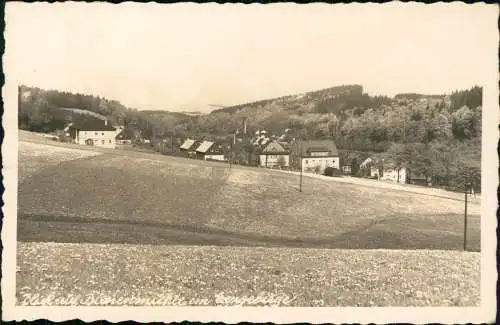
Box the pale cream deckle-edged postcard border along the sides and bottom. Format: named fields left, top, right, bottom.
left=1, top=3, right=499, bottom=324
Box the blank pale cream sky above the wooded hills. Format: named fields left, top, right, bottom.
left=4, top=2, right=498, bottom=111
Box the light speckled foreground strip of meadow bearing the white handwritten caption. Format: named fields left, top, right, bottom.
left=16, top=243, right=480, bottom=307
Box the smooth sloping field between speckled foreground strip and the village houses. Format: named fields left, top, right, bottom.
left=18, top=137, right=480, bottom=251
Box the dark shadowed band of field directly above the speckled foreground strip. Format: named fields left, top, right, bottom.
left=18, top=214, right=480, bottom=251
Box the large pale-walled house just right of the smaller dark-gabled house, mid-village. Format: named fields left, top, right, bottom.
left=291, top=140, right=340, bottom=174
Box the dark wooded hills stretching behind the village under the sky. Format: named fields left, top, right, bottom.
left=19, top=85, right=482, bottom=192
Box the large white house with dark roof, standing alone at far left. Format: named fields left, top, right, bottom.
left=66, top=119, right=116, bottom=149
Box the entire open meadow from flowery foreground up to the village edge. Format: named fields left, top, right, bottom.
left=17, top=131, right=480, bottom=306
